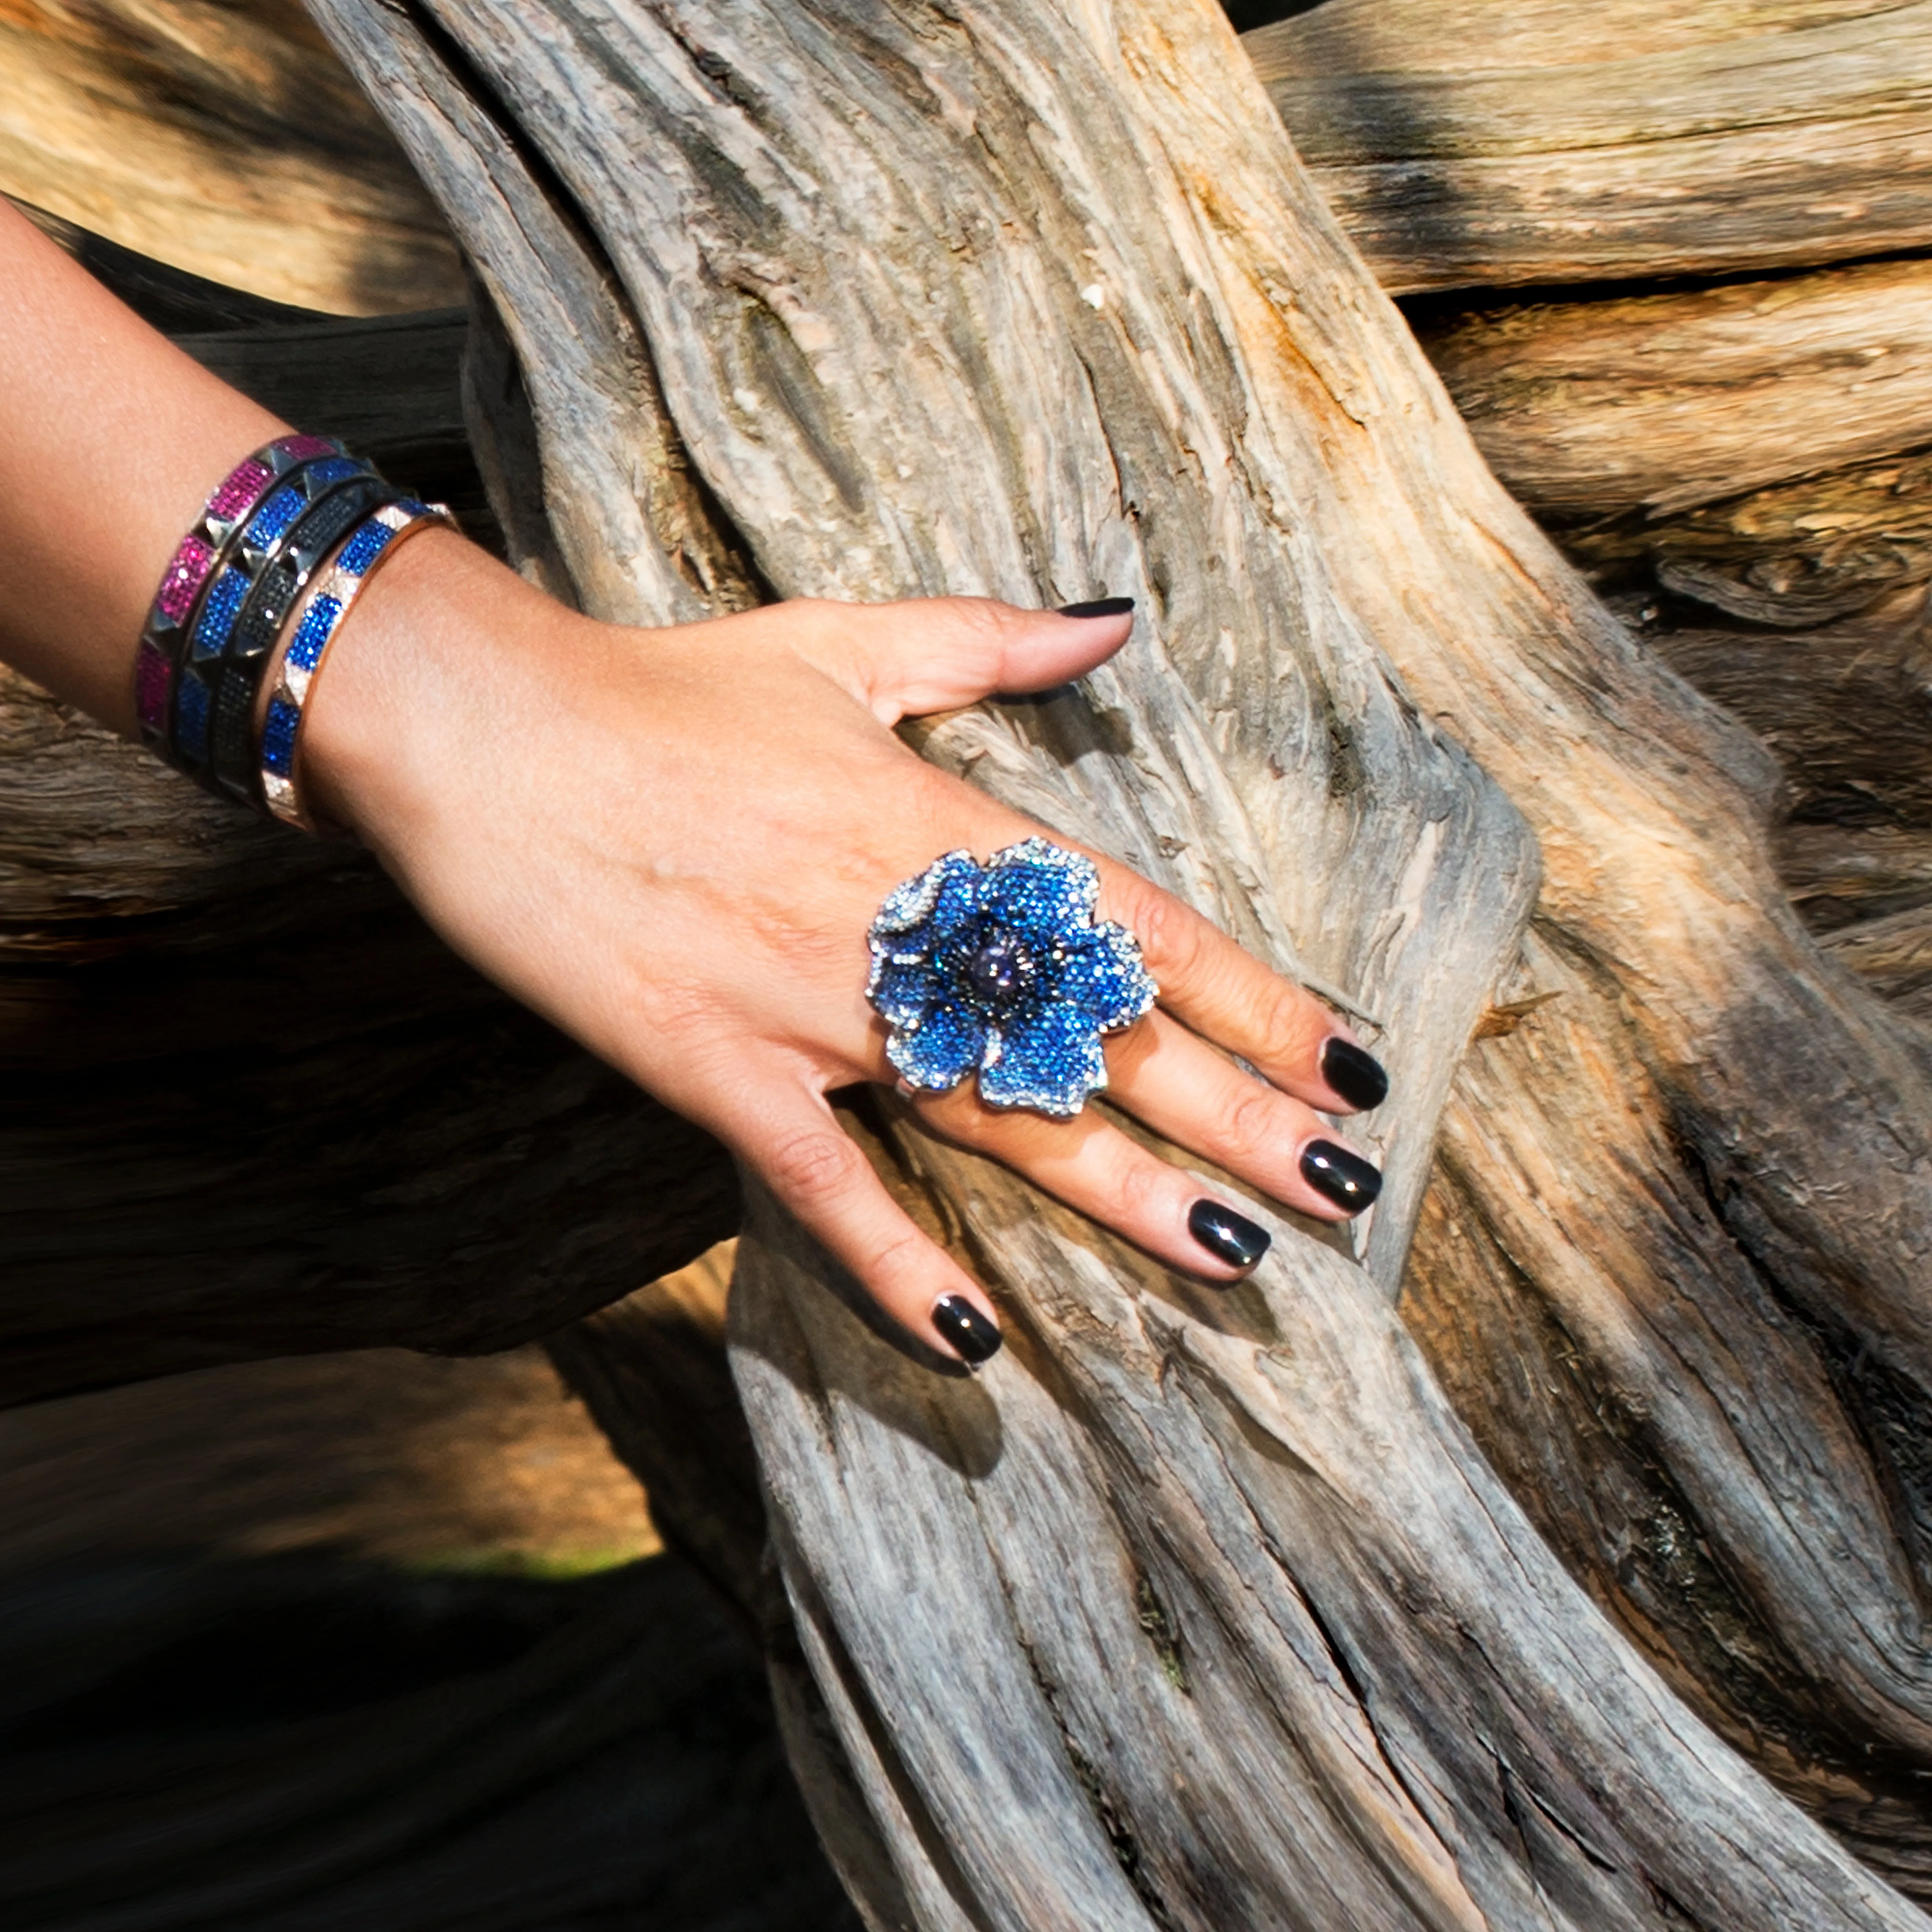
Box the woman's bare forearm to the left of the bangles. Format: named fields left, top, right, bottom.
left=0, top=201, right=288, bottom=734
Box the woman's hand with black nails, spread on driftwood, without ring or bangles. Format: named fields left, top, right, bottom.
left=301, top=533, right=1383, bottom=1360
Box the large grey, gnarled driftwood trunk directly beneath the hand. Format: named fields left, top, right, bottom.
left=305, top=0, right=1932, bottom=1928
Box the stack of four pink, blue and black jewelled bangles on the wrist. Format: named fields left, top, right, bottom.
left=135, top=435, right=448, bottom=823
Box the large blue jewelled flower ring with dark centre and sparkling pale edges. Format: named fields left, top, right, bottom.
left=866, top=839, right=1159, bottom=1121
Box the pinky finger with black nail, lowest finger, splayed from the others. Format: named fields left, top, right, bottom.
left=726, top=1086, right=1003, bottom=1368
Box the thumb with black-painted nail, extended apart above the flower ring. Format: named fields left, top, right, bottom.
left=821, top=597, right=1134, bottom=724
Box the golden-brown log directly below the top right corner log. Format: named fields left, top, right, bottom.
left=1410, top=261, right=1932, bottom=626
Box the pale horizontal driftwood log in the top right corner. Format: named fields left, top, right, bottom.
left=1244, top=0, right=1932, bottom=294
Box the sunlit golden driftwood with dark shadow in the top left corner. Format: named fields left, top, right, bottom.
left=0, top=0, right=462, bottom=315
